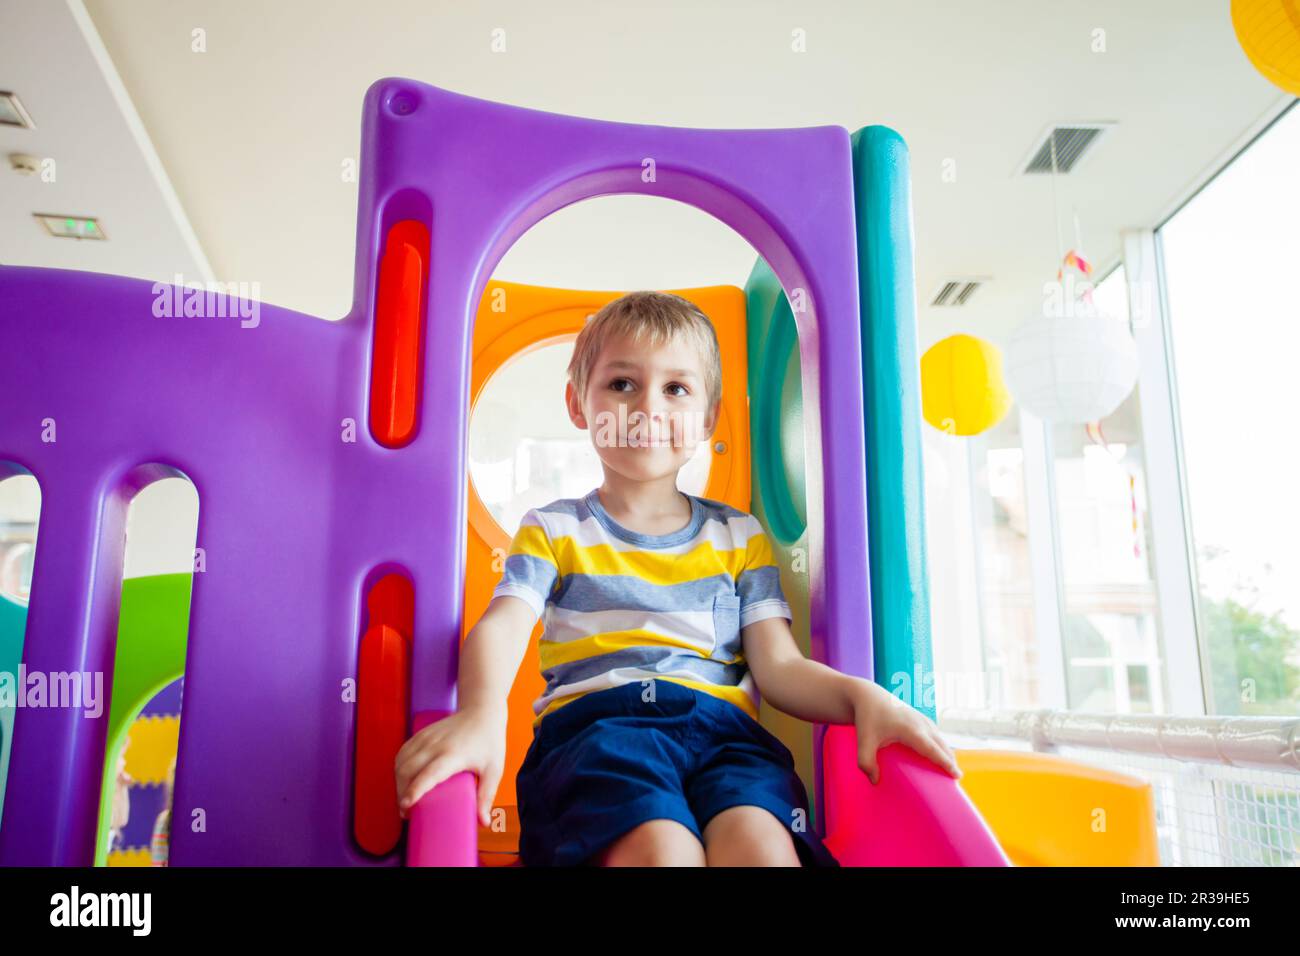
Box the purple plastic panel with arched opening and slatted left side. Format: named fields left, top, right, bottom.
left=0, top=79, right=871, bottom=865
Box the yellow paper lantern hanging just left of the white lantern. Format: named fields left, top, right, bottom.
left=920, top=334, right=1011, bottom=436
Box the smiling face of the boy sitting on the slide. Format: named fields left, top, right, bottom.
left=564, top=330, right=718, bottom=481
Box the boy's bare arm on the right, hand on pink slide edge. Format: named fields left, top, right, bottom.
left=741, top=618, right=962, bottom=784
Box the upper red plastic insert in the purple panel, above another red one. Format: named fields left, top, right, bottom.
left=371, top=220, right=429, bottom=447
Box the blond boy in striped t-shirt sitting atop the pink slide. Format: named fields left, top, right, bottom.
left=397, top=291, right=959, bottom=866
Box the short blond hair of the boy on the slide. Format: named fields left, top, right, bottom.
left=568, top=291, right=723, bottom=410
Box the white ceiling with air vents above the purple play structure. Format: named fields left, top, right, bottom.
left=0, top=0, right=1290, bottom=342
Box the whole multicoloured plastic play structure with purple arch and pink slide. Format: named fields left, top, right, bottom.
left=0, top=78, right=1141, bottom=866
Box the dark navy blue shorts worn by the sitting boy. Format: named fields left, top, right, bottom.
left=517, top=680, right=840, bottom=866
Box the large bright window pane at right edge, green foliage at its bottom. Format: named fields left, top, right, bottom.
left=1158, top=108, right=1300, bottom=714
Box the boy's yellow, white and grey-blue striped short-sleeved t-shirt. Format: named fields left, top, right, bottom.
left=493, top=490, right=790, bottom=727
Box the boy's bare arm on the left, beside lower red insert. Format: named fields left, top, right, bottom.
left=395, top=594, right=537, bottom=826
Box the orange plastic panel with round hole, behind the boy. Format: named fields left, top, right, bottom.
left=462, top=281, right=750, bottom=866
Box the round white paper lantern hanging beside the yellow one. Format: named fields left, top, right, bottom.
left=1004, top=315, right=1138, bottom=424
